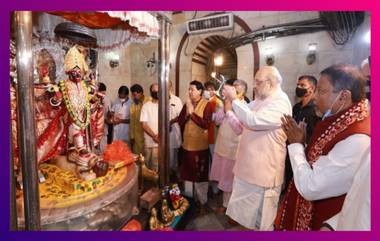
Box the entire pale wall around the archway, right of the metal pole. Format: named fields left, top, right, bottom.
left=170, top=12, right=370, bottom=103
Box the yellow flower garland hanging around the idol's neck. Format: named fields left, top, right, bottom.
left=59, top=80, right=91, bottom=129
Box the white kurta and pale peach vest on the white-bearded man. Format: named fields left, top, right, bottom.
left=232, top=88, right=292, bottom=188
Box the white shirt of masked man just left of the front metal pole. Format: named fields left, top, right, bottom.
left=140, top=101, right=158, bottom=148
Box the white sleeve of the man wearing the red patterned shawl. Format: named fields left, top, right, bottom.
left=288, top=134, right=371, bottom=201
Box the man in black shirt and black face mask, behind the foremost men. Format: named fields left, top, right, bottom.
left=285, top=75, right=321, bottom=190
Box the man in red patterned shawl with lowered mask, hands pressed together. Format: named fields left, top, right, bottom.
left=275, top=65, right=371, bottom=231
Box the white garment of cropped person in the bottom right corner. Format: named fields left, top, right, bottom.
left=327, top=149, right=371, bottom=231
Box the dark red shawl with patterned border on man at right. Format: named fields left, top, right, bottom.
left=275, top=100, right=370, bottom=231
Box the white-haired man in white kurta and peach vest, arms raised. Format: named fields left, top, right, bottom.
left=224, top=66, right=292, bottom=230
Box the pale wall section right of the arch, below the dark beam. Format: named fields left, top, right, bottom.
left=259, top=13, right=369, bottom=103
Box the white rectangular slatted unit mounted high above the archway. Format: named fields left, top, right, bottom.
left=186, top=13, right=234, bottom=34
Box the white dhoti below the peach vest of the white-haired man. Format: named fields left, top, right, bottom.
left=226, top=176, right=281, bottom=230
